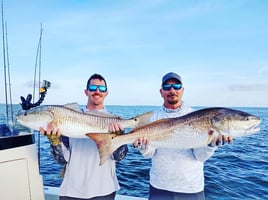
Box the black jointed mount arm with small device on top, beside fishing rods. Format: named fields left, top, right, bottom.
left=20, top=80, right=51, bottom=110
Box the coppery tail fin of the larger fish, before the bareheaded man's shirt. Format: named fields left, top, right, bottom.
left=86, top=133, right=119, bottom=165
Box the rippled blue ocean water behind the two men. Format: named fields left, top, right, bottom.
left=0, top=104, right=268, bottom=200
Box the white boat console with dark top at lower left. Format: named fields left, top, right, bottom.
left=0, top=133, right=44, bottom=200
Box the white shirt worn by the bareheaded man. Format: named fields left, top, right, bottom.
left=60, top=107, right=120, bottom=198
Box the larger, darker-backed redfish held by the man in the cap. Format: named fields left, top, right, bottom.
left=87, top=108, right=261, bottom=164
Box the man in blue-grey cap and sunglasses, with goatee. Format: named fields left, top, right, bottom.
left=133, top=72, right=232, bottom=200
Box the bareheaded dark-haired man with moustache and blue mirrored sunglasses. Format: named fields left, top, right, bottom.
left=40, top=74, right=128, bottom=200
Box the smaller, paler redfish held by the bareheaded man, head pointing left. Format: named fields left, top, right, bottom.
left=16, top=104, right=152, bottom=138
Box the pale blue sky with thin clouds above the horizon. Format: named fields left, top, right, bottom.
left=0, top=0, right=268, bottom=107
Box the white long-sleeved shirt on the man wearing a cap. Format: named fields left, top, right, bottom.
left=141, top=103, right=216, bottom=193
